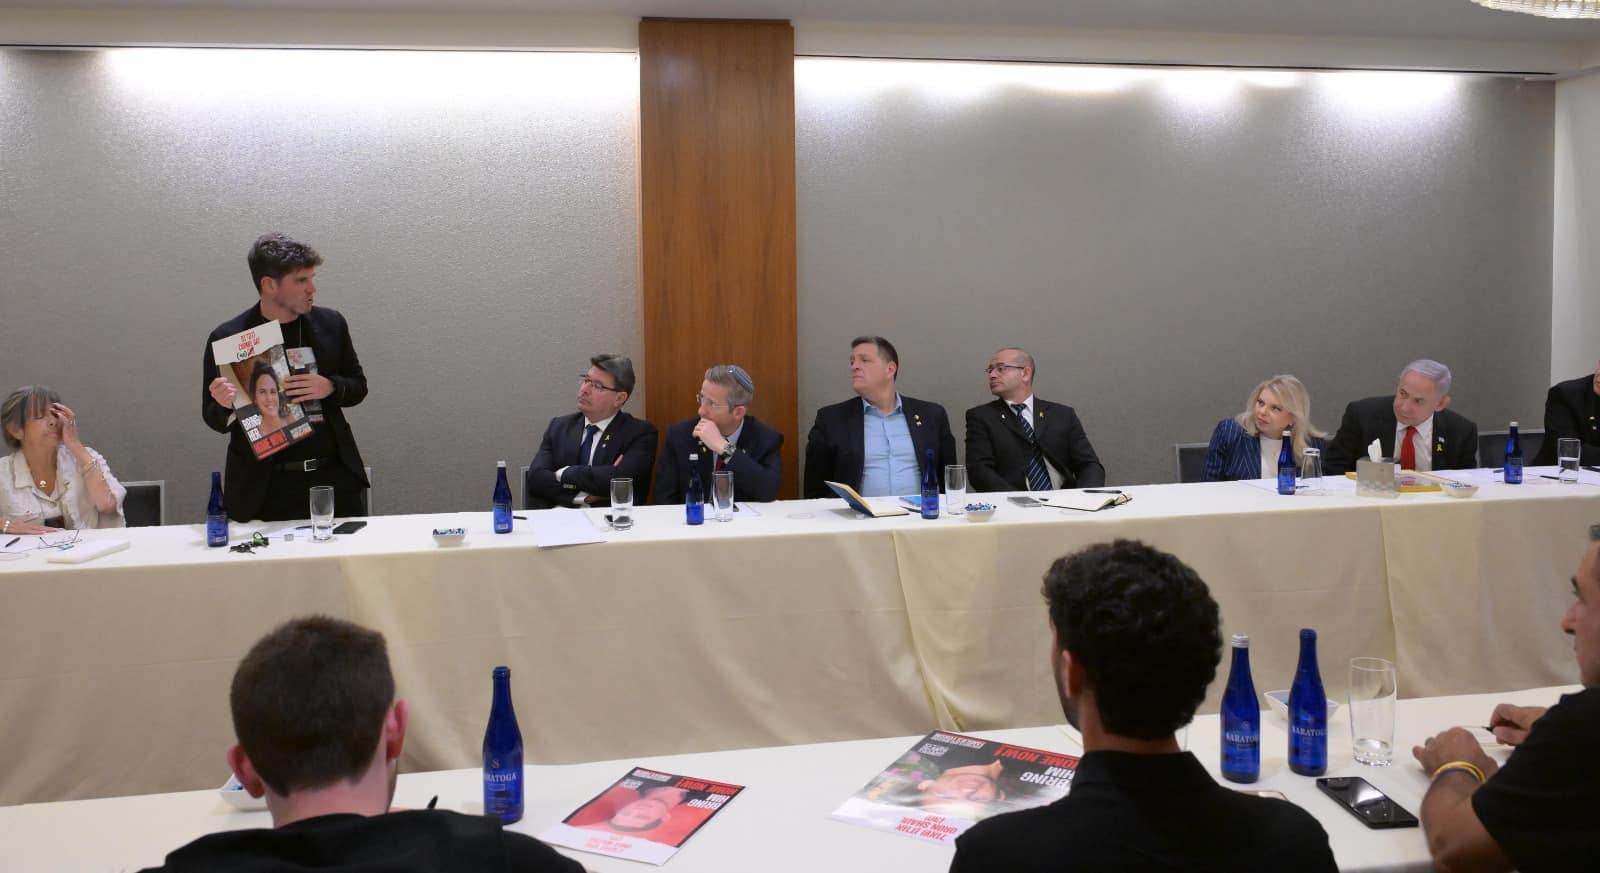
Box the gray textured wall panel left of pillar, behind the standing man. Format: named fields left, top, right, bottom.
left=0, top=50, right=643, bottom=521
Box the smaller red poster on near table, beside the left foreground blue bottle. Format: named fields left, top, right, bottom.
left=539, top=767, right=744, bottom=865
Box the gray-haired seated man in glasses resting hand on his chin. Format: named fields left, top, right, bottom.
left=656, top=365, right=784, bottom=504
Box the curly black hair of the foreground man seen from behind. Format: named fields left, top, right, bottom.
left=1043, top=539, right=1222, bottom=740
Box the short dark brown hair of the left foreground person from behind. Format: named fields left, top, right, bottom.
left=229, top=616, right=395, bottom=796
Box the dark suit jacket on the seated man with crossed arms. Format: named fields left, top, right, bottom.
left=523, top=413, right=659, bottom=508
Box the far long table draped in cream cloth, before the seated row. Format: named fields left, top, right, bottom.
left=0, top=468, right=1600, bottom=804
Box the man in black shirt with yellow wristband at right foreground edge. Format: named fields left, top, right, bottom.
left=1411, top=524, right=1600, bottom=873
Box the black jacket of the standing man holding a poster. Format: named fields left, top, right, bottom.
left=200, top=302, right=371, bottom=521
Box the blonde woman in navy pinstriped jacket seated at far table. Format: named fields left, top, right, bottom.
left=1200, top=376, right=1326, bottom=481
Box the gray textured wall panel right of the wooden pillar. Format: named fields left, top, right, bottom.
left=795, top=59, right=1554, bottom=483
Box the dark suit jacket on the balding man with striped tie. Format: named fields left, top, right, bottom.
left=966, top=397, right=1106, bottom=491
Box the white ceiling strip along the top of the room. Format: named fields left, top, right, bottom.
left=18, top=0, right=1600, bottom=43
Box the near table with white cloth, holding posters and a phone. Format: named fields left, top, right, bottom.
left=0, top=688, right=1576, bottom=873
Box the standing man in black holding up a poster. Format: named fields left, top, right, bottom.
left=200, top=233, right=368, bottom=521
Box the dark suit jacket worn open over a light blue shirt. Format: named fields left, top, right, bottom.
left=805, top=395, right=955, bottom=497
